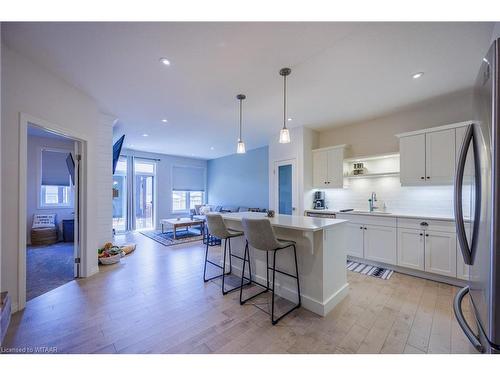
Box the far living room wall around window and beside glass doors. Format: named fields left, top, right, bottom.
left=121, top=149, right=207, bottom=229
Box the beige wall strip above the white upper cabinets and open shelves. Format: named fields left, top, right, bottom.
left=319, top=90, right=474, bottom=156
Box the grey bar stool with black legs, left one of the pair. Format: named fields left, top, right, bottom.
left=203, top=214, right=250, bottom=295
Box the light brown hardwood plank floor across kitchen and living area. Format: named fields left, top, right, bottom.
left=4, top=234, right=474, bottom=353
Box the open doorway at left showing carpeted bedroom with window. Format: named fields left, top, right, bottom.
left=17, top=113, right=87, bottom=310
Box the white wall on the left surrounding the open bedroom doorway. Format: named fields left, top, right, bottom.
left=1, top=45, right=112, bottom=308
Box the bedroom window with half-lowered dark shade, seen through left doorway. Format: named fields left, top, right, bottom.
left=39, top=148, right=73, bottom=208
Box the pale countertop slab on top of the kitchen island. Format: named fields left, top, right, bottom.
left=222, top=212, right=347, bottom=232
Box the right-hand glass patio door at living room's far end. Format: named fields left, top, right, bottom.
left=134, top=158, right=156, bottom=230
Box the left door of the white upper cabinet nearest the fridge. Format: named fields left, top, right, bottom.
left=399, top=134, right=425, bottom=185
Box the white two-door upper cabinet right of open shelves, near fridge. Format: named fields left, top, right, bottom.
left=397, top=122, right=470, bottom=186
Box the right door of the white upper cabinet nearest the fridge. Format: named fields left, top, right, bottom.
left=425, top=129, right=456, bottom=184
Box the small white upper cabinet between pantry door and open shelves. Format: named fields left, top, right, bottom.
left=313, top=145, right=345, bottom=189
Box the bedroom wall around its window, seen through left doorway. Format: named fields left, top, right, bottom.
left=26, top=135, right=75, bottom=244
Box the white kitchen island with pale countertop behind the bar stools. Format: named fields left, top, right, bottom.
left=222, top=212, right=348, bottom=316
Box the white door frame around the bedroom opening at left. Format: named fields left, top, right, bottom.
left=17, top=112, right=88, bottom=310
